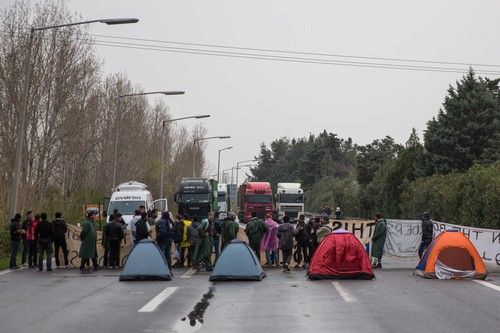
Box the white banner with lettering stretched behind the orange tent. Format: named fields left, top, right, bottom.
left=384, top=219, right=500, bottom=269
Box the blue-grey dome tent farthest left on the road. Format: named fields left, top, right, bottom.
left=120, top=239, right=172, bottom=281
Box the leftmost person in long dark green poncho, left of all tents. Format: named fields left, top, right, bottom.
left=79, top=209, right=99, bottom=273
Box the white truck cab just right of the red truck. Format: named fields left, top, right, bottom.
left=275, top=183, right=304, bottom=220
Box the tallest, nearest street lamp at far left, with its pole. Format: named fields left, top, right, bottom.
left=10, top=18, right=139, bottom=216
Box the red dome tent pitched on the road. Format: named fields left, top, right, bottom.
left=307, top=230, right=375, bottom=280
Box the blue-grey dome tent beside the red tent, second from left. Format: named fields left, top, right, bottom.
left=210, top=239, right=266, bottom=281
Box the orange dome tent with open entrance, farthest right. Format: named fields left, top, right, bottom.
left=415, top=229, right=486, bottom=279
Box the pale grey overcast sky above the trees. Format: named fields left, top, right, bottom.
left=0, top=0, right=500, bottom=182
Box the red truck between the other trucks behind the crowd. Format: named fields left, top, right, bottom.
left=238, top=182, right=274, bottom=222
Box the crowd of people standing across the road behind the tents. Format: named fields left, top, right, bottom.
left=6, top=206, right=433, bottom=273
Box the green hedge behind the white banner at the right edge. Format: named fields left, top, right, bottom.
left=401, top=162, right=500, bottom=229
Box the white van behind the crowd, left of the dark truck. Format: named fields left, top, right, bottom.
left=106, top=181, right=168, bottom=224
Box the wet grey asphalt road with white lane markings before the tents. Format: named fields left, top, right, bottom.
left=0, top=262, right=500, bottom=333
